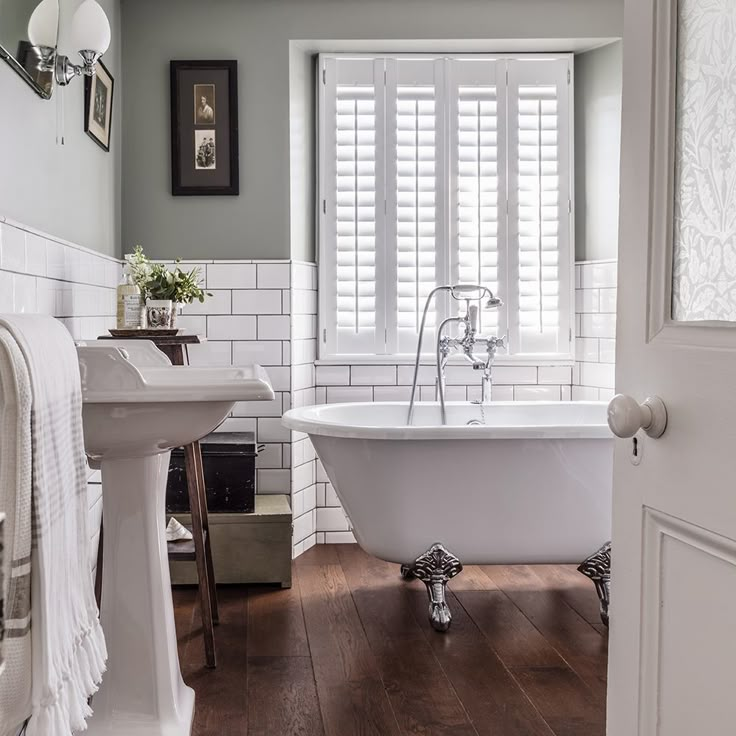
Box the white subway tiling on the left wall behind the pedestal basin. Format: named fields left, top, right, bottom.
left=0, top=216, right=122, bottom=575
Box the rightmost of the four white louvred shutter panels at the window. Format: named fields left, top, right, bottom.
left=508, top=60, right=572, bottom=354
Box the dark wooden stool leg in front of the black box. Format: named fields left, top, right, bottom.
left=184, top=442, right=218, bottom=667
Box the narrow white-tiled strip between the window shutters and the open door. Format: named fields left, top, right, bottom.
left=572, top=261, right=617, bottom=401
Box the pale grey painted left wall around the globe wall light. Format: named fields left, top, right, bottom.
left=0, top=0, right=122, bottom=255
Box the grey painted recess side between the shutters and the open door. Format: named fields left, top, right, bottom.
left=575, top=41, right=622, bottom=260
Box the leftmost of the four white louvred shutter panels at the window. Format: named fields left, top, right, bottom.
left=322, top=59, right=385, bottom=354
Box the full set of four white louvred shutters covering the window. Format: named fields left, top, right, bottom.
left=318, top=55, right=573, bottom=359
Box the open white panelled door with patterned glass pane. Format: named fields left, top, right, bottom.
left=608, top=0, right=736, bottom=736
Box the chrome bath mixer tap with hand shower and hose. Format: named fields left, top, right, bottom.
left=407, top=284, right=505, bottom=424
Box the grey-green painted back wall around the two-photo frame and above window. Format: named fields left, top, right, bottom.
left=122, top=0, right=623, bottom=258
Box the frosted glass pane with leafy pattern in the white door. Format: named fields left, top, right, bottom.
left=672, top=0, right=736, bottom=321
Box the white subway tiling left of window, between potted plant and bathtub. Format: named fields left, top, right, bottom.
left=175, top=260, right=317, bottom=556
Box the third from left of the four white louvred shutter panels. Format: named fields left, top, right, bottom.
left=450, top=59, right=507, bottom=336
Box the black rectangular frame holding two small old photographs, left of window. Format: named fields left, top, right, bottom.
left=171, top=61, right=240, bottom=196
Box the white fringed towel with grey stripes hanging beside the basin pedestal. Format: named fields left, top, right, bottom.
left=0, top=315, right=107, bottom=736
